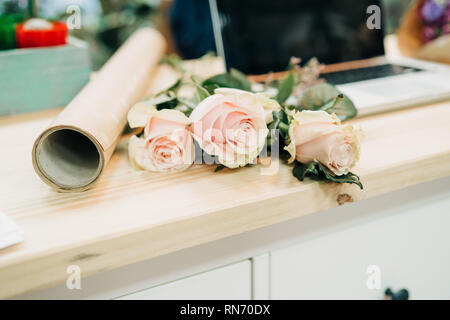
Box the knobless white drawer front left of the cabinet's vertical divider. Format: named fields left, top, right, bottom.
left=118, top=260, right=251, bottom=300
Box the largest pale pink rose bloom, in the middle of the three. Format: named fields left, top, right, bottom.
left=189, top=89, right=272, bottom=168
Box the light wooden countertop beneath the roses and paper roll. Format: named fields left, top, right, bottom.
left=0, top=101, right=450, bottom=298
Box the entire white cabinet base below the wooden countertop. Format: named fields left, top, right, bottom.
left=17, top=178, right=450, bottom=299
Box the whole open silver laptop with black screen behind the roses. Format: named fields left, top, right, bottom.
left=209, top=0, right=450, bottom=116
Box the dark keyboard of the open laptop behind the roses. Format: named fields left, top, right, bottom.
left=320, top=64, right=423, bottom=85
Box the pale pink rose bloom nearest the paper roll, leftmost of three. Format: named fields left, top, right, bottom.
left=128, top=103, right=194, bottom=172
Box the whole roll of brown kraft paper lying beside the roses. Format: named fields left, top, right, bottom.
left=32, top=28, right=166, bottom=192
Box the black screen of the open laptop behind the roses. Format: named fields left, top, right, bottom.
left=210, top=0, right=384, bottom=74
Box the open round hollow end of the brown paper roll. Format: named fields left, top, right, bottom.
left=33, top=127, right=105, bottom=192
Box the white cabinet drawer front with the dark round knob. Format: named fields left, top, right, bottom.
left=271, top=184, right=450, bottom=299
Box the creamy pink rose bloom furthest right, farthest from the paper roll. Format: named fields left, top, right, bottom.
left=285, top=111, right=362, bottom=176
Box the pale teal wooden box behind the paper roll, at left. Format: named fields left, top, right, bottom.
left=0, top=38, right=91, bottom=116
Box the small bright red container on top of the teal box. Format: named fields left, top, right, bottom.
left=16, top=22, right=68, bottom=48
